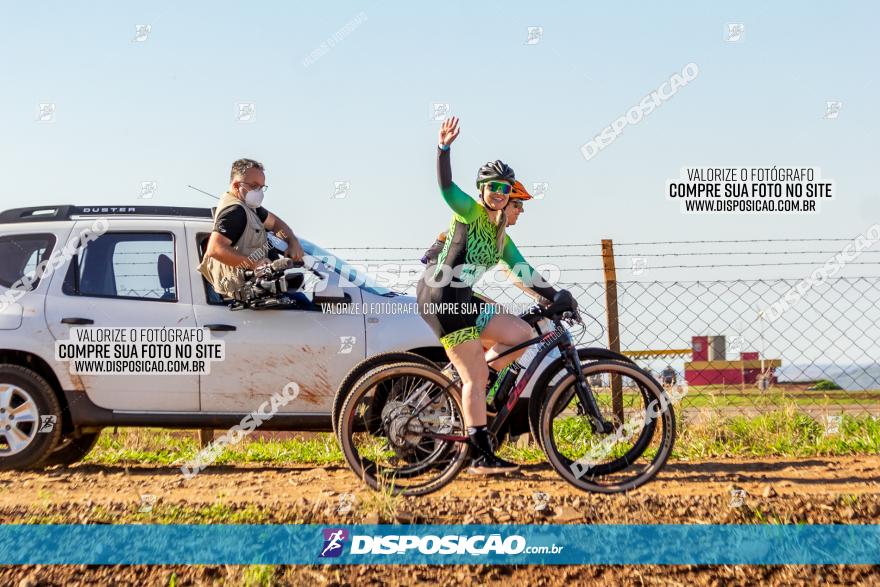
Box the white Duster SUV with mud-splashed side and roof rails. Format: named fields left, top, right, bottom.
left=0, top=205, right=454, bottom=469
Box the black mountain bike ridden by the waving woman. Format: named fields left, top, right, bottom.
left=337, top=298, right=675, bottom=495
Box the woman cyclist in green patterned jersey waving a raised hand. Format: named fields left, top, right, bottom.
left=417, top=117, right=558, bottom=475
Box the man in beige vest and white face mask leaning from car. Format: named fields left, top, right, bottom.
left=199, top=159, right=304, bottom=298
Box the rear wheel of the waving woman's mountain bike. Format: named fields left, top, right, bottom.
left=337, top=363, right=468, bottom=495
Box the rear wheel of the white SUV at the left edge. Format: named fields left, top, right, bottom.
left=0, top=363, right=61, bottom=470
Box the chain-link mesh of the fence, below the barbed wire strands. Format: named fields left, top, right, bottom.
left=572, top=277, right=880, bottom=417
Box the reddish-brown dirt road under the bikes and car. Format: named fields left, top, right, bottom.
left=0, top=456, right=880, bottom=587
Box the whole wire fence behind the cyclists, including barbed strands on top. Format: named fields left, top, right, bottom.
left=336, top=239, right=880, bottom=420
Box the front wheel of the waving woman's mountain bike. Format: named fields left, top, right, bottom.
left=540, top=361, right=675, bottom=493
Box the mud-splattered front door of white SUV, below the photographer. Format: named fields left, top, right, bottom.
left=187, top=222, right=366, bottom=414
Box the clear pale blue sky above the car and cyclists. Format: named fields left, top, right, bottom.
left=0, top=1, right=880, bottom=277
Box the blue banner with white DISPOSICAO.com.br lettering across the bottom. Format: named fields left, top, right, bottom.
left=0, top=524, right=880, bottom=565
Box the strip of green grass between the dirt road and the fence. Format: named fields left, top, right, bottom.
left=85, top=404, right=880, bottom=466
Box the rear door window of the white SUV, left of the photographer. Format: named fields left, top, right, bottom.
left=64, top=232, right=177, bottom=302
